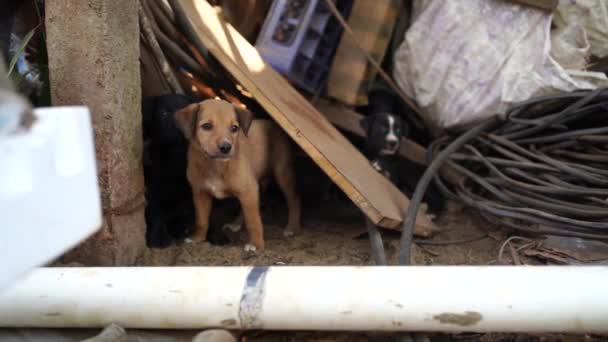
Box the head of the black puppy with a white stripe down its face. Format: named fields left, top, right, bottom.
left=361, top=113, right=409, bottom=156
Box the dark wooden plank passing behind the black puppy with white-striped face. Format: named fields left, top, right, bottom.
left=315, top=99, right=463, bottom=184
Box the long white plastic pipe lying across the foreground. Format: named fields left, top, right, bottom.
left=0, top=266, right=608, bottom=333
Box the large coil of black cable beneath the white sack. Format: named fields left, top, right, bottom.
left=432, top=88, right=608, bottom=240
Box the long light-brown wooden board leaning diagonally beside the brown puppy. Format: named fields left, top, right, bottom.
left=181, top=0, right=434, bottom=233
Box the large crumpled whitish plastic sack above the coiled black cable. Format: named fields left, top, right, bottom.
left=393, top=0, right=608, bottom=131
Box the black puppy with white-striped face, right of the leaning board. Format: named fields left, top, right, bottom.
left=361, top=112, right=444, bottom=216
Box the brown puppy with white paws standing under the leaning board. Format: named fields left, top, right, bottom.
left=175, top=100, right=300, bottom=251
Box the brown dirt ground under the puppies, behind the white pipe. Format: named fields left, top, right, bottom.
left=138, top=196, right=501, bottom=266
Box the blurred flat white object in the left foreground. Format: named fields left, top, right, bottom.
left=0, top=107, right=102, bottom=290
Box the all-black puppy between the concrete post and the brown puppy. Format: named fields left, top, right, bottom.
left=142, top=95, right=228, bottom=247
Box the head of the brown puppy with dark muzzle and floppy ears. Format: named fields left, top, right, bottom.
left=175, top=100, right=253, bottom=159
